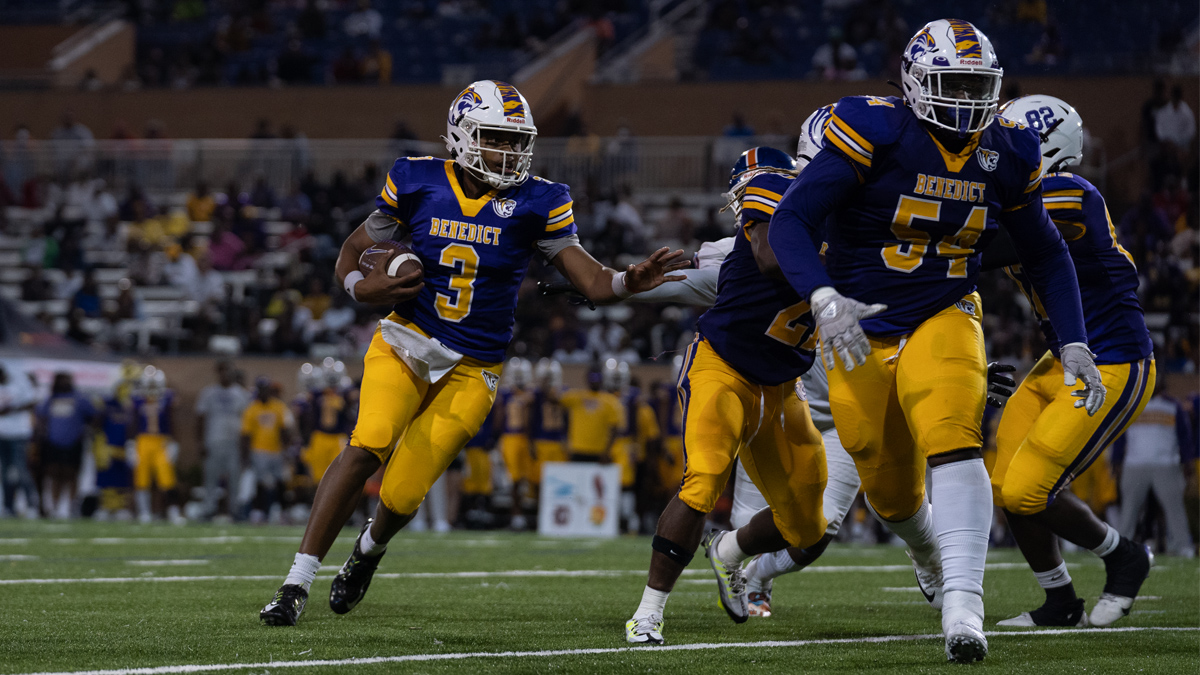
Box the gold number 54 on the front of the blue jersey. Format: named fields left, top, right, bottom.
left=880, top=195, right=988, bottom=277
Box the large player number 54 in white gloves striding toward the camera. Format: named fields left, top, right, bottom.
left=769, top=19, right=1104, bottom=662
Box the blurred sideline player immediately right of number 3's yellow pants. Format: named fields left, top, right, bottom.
left=496, top=357, right=534, bottom=530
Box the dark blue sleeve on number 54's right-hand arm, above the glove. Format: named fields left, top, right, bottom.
left=1000, top=199, right=1087, bottom=345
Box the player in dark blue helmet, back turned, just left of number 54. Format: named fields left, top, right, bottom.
left=625, top=148, right=826, bottom=644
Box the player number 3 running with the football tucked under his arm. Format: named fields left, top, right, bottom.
left=266, top=80, right=684, bottom=626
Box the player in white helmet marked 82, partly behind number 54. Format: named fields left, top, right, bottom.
left=984, top=96, right=1154, bottom=627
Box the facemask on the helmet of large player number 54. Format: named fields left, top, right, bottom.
left=905, top=61, right=1003, bottom=138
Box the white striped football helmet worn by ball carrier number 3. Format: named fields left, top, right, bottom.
left=442, top=79, right=538, bottom=190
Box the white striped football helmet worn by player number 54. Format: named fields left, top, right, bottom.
left=900, top=19, right=1004, bottom=136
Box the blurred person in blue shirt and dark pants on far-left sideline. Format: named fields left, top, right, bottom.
left=35, top=372, right=97, bottom=519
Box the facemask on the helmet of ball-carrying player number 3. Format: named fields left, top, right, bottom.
left=451, top=117, right=538, bottom=190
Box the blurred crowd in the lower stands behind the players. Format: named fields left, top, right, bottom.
left=0, top=82, right=1200, bottom=372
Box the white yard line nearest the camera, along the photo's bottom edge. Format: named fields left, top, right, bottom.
left=11, top=627, right=1200, bottom=675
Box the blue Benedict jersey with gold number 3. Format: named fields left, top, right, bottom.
left=376, top=157, right=575, bottom=363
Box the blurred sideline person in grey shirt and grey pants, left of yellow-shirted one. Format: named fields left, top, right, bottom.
left=196, top=360, right=250, bottom=518
